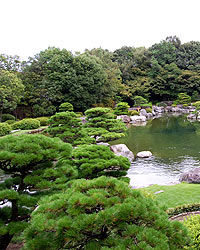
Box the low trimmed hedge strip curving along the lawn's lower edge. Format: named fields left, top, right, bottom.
left=166, top=203, right=200, bottom=217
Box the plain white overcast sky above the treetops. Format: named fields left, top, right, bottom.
left=0, top=0, right=200, bottom=60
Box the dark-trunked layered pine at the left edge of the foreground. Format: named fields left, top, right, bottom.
left=0, top=135, right=72, bottom=250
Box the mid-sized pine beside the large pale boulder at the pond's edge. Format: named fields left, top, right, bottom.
left=72, top=145, right=130, bottom=179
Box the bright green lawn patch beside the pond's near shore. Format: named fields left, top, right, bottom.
left=141, top=183, right=200, bottom=209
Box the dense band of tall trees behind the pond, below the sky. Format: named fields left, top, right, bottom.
left=0, top=36, right=200, bottom=118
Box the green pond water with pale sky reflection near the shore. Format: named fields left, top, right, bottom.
left=110, top=115, right=200, bottom=187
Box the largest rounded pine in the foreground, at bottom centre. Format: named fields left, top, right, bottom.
left=24, top=177, right=188, bottom=250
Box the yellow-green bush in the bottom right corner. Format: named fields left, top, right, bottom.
left=183, top=214, right=200, bottom=250
